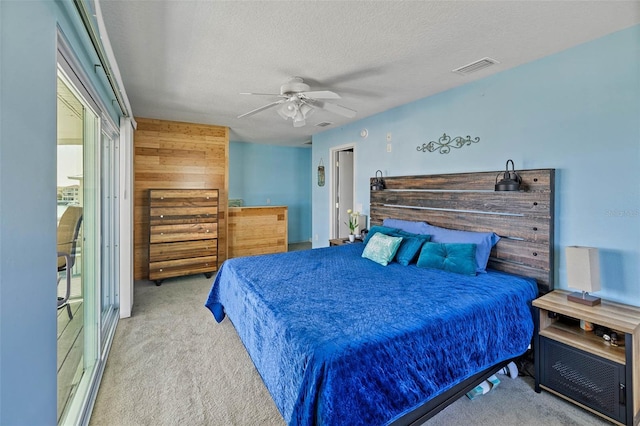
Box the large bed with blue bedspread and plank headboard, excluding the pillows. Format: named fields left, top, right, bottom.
left=206, top=169, right=554, bottom=425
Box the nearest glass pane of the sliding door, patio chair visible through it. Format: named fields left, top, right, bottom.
left=57, top=74, right=92, bottom=420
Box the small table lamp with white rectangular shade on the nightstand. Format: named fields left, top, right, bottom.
left=565, top=246, right=600, bottom=306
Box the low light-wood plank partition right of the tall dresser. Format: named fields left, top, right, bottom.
left=228, top=206, right=288, bottom=258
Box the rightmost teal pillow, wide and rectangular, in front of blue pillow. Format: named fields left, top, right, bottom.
left=418, top=243, right=476, bottom=276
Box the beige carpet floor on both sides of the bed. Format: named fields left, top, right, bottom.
left=90, top=275, right=610, bottom=426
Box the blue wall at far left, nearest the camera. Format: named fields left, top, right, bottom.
left=0, top=0, right=124, bottom=425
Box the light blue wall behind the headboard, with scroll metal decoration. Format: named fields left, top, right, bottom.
left=310, top=26, right=640, bottom=306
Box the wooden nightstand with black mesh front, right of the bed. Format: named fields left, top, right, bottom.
left=533, top=290, right=640, bottom=425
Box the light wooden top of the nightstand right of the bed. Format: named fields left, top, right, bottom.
left=533, top=290, right=640, bottom=334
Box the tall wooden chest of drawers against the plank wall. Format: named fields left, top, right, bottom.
left=149, top=189, right=218, bottom=285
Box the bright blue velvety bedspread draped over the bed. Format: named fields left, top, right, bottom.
left=206, top=244, right=537, bottom=425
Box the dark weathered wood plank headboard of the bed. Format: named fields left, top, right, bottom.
left=369, top=169, right=555, bottom=294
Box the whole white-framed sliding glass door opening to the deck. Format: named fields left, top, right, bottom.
left=57, top=56, right=119, bottom=425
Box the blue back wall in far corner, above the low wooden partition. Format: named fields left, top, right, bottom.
left=229, top=141, right=311, bottom=243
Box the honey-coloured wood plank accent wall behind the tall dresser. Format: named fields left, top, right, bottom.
left=134, top=118, right=229, bottom=280
